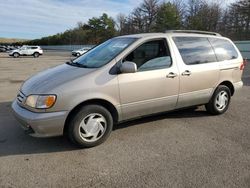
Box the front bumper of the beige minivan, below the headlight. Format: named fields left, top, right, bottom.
left=12, top=100, right=68, bottom=137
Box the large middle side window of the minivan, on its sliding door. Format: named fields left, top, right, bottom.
left=173, top=37, right=217, bottom=65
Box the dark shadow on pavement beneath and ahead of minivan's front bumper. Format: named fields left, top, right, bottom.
left=0, top=102, right=78, bottom=157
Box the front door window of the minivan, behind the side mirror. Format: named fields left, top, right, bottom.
left=123, top=39, right=172, bottom=71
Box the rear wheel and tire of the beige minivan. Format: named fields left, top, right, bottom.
left=205, top=85, right=231, bottom=115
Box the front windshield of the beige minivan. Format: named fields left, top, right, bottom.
left=73, top=38, right=136, bottom=68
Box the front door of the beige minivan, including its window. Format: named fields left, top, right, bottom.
left=118, top=39, right=179, bottom=119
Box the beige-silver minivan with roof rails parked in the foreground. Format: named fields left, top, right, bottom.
left=12, top=30, right=244, bottom=147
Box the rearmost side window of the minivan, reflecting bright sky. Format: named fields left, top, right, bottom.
left=209, top=38, right=238, bottom=61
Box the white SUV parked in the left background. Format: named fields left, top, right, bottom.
left=9, top=46, right=43, bottom=58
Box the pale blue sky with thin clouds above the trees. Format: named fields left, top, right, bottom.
left=0, top=0, right=236, bottom=39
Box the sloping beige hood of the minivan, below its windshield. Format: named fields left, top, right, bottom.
left=21, top=64, right=95, bottom=96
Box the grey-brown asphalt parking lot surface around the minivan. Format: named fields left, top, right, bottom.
left=0, top=51, right=250, bottom=188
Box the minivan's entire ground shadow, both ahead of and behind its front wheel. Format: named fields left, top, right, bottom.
left=0, top=102, right=208, bottom=157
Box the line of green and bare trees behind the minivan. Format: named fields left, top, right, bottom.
left=26, top=0, right=250, bottom=45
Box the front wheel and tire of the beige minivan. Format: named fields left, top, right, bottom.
left=68, top=104, right=113, bottom=148
